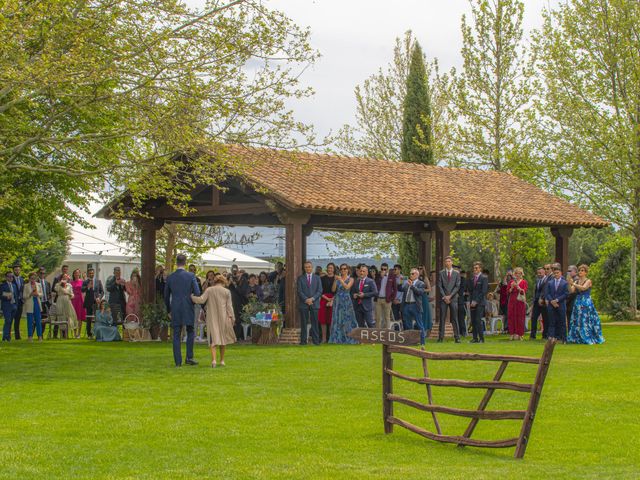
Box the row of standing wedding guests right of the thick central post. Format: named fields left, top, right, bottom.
left=296, top=257, right=604, bottom=345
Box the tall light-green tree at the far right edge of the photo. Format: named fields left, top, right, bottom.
left=531, top=0, right=640, bottom=311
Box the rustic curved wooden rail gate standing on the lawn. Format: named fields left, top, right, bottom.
left=382, top=340, right=555, bottom=458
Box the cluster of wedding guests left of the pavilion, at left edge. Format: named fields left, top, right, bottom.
left=0, top=263, right=141, bottom=342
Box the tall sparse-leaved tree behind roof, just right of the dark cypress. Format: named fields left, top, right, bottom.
left=449, top=0, right=532, bottom=276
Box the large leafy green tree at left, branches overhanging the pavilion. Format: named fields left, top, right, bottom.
left=0, top=0, right=317, bottom=270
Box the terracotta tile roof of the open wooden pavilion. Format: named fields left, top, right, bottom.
left=228, top=145, right=609, bottom=227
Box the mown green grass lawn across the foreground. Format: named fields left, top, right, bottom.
left=0, top=326, right=640, bottom=480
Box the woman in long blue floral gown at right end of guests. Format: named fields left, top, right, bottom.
left=567, top=265, right=604, bottom=345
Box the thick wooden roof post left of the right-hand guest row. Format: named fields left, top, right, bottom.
left=278, top=212, right=309, bottom=328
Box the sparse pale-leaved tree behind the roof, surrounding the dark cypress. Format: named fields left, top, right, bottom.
left=326, top=31, right=450, bottom=268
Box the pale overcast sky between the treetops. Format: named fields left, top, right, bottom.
left=187, top=0, right=559, bottom=137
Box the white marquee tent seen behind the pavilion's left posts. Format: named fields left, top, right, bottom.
left=61, top=218, right=273, bottom=282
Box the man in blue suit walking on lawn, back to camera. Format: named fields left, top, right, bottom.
left=164, top=254, right=200, bottom=367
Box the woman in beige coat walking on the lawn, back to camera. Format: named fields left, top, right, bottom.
left=191, top=275, right=236, bottom=368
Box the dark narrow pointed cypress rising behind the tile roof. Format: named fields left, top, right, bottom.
left=400, top=42, right=434, bottom=165
